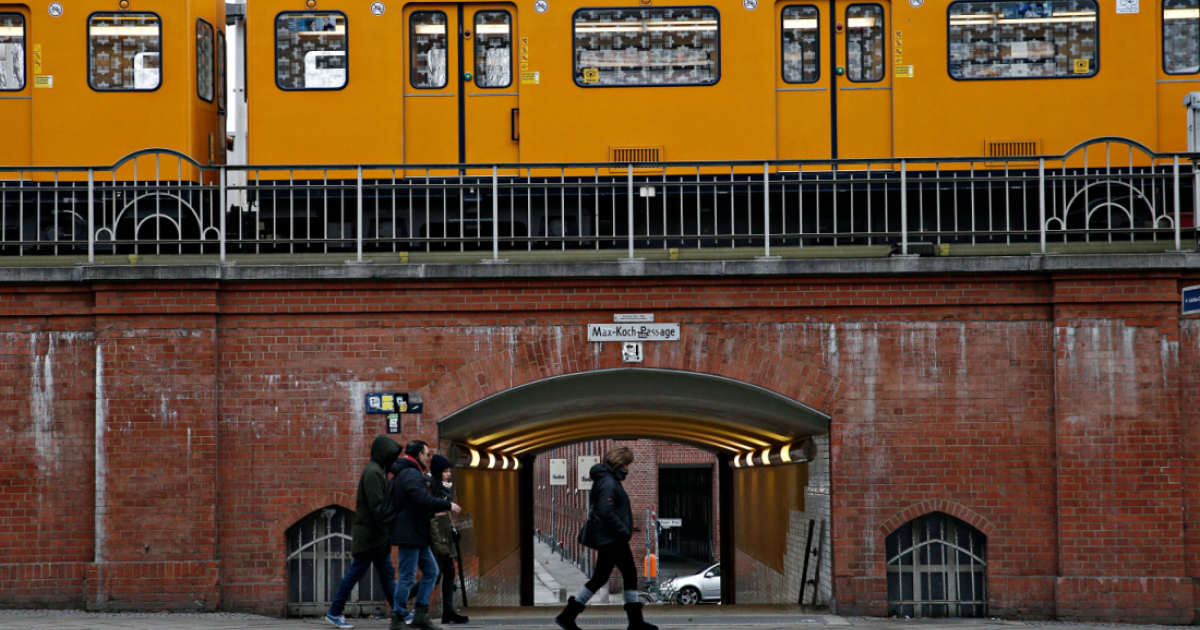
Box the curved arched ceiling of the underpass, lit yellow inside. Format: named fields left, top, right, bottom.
left=438, top=368, right=829, bottom=456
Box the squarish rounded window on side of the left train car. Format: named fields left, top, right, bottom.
left=88, top=12, right=162, bottom=91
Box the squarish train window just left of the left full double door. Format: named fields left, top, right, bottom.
left=275, top=11, right=349, bottom=90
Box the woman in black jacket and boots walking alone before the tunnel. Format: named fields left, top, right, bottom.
left=554, top=446, right=659, bottom=630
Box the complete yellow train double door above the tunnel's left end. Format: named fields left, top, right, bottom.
left=404, top=2, right=520, bottom=164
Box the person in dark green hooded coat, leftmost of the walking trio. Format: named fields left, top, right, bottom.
left=325, top=436, right=401, bottom=629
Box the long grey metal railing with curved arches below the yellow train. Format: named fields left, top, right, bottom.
left=0, top=138, right=1200, bottom=263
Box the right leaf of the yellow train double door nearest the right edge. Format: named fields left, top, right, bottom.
left=833, top=0, right=894, bottom=158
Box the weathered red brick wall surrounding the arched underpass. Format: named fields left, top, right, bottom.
left=0, top=271, right=1200, bottom=623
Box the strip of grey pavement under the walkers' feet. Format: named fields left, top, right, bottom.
left=0, top=606, right=1180, bottom=630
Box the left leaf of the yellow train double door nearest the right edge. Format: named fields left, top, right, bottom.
left=775, top=0, right=833, bottom=160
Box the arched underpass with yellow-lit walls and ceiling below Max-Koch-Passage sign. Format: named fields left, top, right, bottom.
left=438, top=368, right=829, bottom=606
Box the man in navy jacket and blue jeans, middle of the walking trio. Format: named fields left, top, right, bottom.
left=391, top=440, right=462, bottom=630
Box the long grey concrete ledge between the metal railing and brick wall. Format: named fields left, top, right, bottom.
left=0, top=252, right=1200, bottom=284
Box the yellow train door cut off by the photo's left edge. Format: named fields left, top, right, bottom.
left=0, top=5, right=30, bottom=166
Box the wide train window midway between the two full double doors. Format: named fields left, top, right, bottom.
left=574, top=6, right=721, bottom=88
